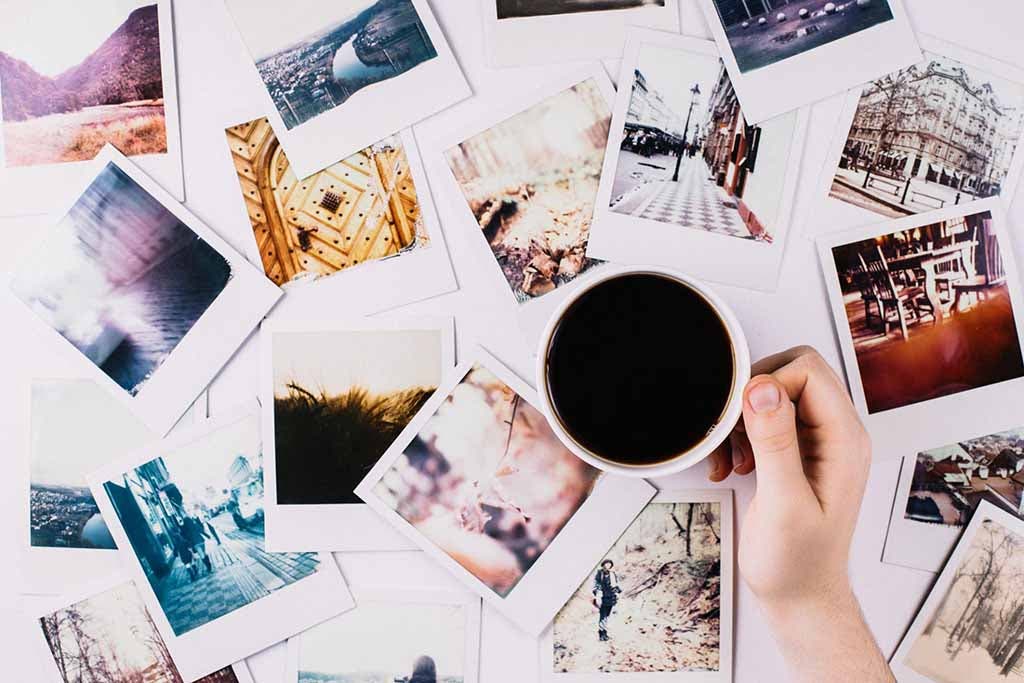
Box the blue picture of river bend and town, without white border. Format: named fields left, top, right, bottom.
left=228, top=0, right=437, bottom=130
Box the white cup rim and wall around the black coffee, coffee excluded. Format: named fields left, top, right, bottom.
left=537, top=265, right=751, bottom=478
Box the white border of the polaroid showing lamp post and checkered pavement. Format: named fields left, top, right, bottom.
left=587, top=29, right=810, bottom=292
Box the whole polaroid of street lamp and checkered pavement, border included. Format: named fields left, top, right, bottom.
left=587, top=29, right=809, bottom=291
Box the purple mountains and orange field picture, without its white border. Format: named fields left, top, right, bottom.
left=0, top=0, right=167, bottom=167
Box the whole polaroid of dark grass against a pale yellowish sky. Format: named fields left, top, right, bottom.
left=260, top=317, right=455, bottom=552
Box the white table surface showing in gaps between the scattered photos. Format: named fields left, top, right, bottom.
left=0, top=0, right=1024, bottom=683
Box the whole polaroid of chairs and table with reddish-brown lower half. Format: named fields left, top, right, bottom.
left=818, top=198, right=1024, bottom=455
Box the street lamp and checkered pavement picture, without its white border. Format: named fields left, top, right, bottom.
left=609, top=42, right=797, bottom=243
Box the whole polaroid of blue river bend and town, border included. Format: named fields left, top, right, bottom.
left=225, top=0, right=472, bottom=178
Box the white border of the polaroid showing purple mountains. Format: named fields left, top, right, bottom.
left=0, top=0, right=185, bottom=216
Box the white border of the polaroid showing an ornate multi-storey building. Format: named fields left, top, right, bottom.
left=805, top=34, right=1024, bottom=239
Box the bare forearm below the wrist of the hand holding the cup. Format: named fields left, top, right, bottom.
left=762, top=584, right=896, bottom=683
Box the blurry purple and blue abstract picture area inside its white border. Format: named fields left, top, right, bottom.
left=11, top=163, right=232, bottom=395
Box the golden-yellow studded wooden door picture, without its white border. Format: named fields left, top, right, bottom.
left=225, top=119, right=430, bottom=287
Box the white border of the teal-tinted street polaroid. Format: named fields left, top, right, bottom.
left=89, top=410, right=355, bottom=680
